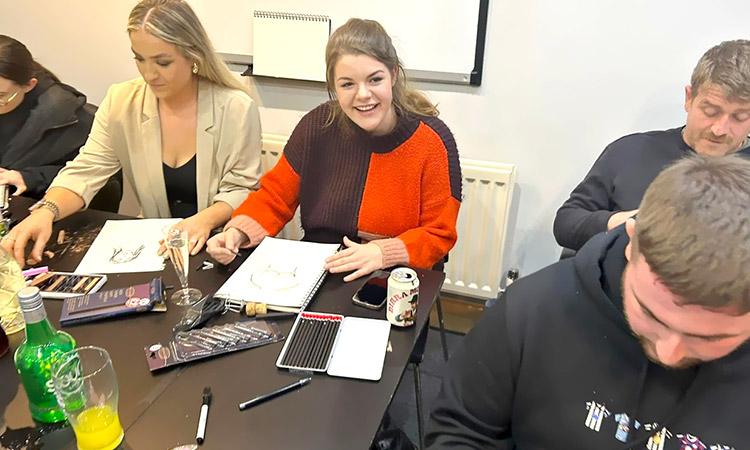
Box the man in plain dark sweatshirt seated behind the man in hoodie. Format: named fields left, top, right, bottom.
left=553, top=40, right=750, bottom=250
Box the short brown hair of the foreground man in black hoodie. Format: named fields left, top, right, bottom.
left=633, top=155, right=750, bottom=314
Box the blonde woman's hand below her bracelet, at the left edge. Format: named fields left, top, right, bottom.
left=0, top=208, right=55, bottom=268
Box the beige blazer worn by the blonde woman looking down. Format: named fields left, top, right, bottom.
left=50, top=78, right=261, bottom=218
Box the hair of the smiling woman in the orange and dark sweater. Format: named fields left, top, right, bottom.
left=326, top=18, right=438, bottom=124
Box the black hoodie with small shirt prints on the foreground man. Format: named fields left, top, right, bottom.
left=426, top=227, right=750, bottom=450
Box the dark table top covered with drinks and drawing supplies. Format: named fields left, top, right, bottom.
left=0, top=199, right=444, bottom=450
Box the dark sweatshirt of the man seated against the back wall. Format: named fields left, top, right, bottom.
left=553, top=127, right=750, bottom=250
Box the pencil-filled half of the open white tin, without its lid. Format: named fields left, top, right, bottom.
left=276, top=312, right=344, bottom=372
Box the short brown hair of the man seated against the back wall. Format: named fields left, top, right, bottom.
left=690, top=39, right=750, bottom=102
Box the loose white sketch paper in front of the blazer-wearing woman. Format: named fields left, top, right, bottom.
left=75, top=218, right=182, bottom=273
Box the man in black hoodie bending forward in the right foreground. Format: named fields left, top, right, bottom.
left=426, top=155, right=750, bottom=450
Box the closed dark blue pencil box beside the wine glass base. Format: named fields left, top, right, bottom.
left=60, top=278, right=167, bottom=327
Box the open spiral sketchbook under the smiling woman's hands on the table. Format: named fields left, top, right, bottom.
left=216, top=237, right=339, bottom=312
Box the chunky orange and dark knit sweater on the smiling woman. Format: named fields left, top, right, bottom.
left=226, top=103, right=461, bottom=268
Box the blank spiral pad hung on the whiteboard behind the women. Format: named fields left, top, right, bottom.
left=253, top=11, right=331, bottom=81
